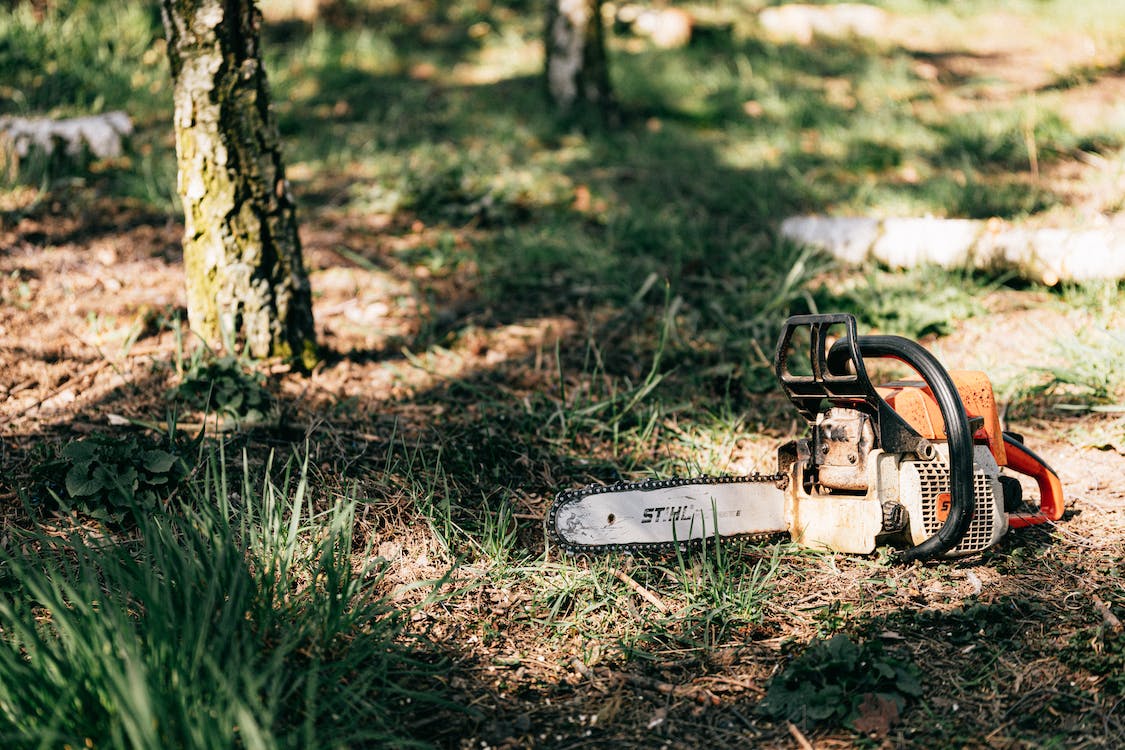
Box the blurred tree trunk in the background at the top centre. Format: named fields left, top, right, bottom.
left=546, top=0, right=613, bottom=120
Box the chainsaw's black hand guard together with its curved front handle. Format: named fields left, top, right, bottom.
left=774, top=314, right=974, bottom=562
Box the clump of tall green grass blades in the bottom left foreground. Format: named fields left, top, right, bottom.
left=0, top=455, right=447, bottom=748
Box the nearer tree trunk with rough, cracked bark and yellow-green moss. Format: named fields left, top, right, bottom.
left=161, top=0, right=316, bottom=365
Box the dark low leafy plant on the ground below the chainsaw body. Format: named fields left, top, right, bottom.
left=758, top=633, right=921, bottom=726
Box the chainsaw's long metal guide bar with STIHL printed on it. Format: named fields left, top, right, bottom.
left=547, top=473, right=789, bottom=554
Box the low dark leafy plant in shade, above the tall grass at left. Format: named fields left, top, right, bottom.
left=33, top=433, right=190, bottom=523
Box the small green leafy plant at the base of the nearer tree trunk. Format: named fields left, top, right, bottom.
left=168, top=356, right=275, bottom=426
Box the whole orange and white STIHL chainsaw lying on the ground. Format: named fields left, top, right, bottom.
left=547, top=314, right=1063, bottom=562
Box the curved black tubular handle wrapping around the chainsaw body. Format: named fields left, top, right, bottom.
left=828, top=335, right=975, bottom=562
